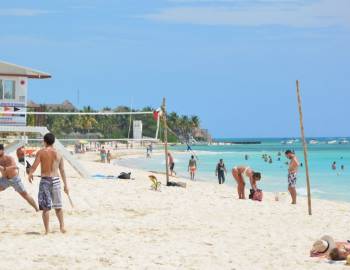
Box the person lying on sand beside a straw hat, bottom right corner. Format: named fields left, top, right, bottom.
left=310, top=235, right=350, bottom=261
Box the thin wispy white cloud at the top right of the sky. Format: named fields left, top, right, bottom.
left=145, top=0, right=350, bottom=27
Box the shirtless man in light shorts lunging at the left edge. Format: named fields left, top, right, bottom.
left=0, top=144, right=39, bottom=211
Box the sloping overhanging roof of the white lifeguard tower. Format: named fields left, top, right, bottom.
left=0, top=60, right=51, bottom=79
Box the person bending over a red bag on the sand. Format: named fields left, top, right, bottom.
left=232, top=166, right=261, bottom=200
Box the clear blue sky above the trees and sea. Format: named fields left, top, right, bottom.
left=0, top=0, right=350, bottom=137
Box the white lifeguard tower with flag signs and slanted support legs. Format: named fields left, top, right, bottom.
left=0, top=61, right=89, bottom=178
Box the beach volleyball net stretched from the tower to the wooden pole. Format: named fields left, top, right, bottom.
left=2, top=109, right=160, bottom=148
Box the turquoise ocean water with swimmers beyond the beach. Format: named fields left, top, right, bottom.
left=118, top=138, right=350, bottom=202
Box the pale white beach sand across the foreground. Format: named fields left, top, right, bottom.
left=0, top=151, right=350, bottom=270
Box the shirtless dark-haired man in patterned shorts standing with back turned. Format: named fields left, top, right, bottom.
left=28, top=133, right=69, bottom=234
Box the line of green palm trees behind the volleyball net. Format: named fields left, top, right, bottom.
left=27, top=106, right=200, bottom=142
